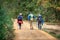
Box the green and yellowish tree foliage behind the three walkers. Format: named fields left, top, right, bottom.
left=0, top=0, right=60, bottom=22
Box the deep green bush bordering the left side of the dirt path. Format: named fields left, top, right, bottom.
left=0, top=6, right=14, bottom=40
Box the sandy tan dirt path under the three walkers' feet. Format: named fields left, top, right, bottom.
left=14, top=20, right=57, bottom=40
